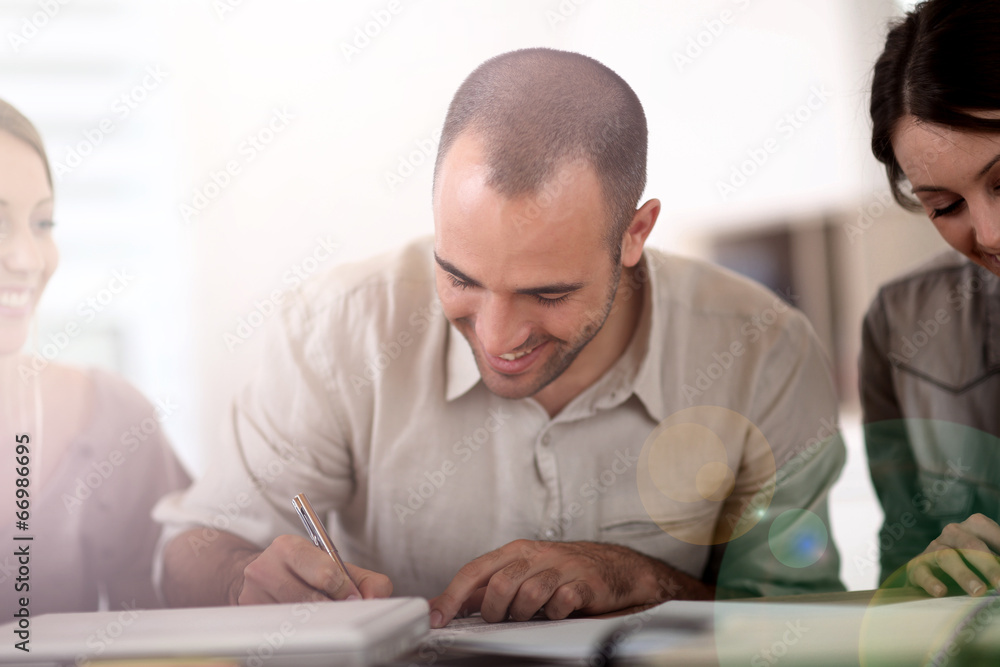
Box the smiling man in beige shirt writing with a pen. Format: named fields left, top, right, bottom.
left=157, top=49, right=843, bottom=627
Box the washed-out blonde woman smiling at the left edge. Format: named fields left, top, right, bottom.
left=0, top=100, right=188, bottom=620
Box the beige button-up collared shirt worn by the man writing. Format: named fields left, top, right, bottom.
left=155, top=238, right=844, bottom=597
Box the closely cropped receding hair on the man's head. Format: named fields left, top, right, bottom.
left=434, top=49, right=647, bottom=263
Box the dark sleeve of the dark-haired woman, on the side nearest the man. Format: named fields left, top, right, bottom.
left=858, top=293, right=939, bottom=585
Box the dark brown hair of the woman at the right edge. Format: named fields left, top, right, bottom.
left=870, top=0, right=1000, bottom=210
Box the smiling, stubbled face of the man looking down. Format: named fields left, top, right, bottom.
left=434, top=132, right=621, bottom=398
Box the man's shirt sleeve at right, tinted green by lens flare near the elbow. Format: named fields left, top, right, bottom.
left=709, top=311, right=846, bottom=597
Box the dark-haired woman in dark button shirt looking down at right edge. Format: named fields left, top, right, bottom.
left=860, top=0, right=1000, bottom=596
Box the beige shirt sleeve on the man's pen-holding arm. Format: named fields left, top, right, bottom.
left=154, top=292, right=355, bottom=568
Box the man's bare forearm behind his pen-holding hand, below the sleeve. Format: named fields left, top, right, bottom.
left=163, top=528, right=260, bottom=607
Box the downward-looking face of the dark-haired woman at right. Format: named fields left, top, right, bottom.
left=892, top=114, right=1000, bottom=275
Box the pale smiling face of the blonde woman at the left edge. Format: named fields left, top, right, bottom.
left=0, top=131, right=59, bottom=357
